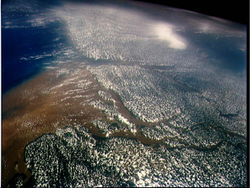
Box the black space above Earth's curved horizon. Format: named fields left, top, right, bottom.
left=134, top=0, right=249, bottom=24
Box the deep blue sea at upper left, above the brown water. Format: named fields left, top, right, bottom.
left=2, top=0, right=70, bottom=93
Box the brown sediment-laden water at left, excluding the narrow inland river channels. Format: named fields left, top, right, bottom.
left=2, top=65, right=104, bottom=186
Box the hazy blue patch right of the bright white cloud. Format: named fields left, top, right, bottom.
left=189, top=33, right=246, bottom=74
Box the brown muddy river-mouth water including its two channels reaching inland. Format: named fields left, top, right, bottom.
left=2, top=64, right=172, bottom=186
